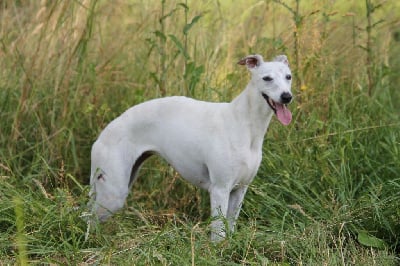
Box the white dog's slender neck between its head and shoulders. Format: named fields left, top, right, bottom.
left=231, top=83, right=274, bottom=146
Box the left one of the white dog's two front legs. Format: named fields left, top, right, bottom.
left=210, top=188, right=230, bottom=242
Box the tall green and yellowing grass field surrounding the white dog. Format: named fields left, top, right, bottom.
left=0, top=0, right=400, bottom=265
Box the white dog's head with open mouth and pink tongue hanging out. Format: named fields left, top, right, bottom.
left=238, top=54, right=293, bottom=125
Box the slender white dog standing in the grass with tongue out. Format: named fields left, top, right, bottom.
left=90, top=55, right=292, bottom=241
